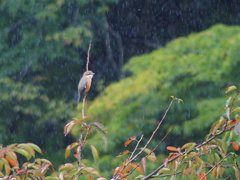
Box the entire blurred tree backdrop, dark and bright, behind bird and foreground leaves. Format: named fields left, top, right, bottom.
left=0, top=0, right=240, bottom=177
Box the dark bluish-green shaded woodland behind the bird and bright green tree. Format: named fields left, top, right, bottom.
left=0, top=0, right=239, bottom=167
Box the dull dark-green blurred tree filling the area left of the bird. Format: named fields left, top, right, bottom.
left=0, top=0, right=115, bottom=165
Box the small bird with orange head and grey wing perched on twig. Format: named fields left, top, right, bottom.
left=77, top=71, right=94, bottom=104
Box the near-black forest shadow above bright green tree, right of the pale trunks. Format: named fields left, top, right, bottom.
left=107, top=0, right=240, bottom=70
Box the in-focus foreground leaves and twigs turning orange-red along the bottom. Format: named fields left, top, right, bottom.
left=0, top=86, right=240, bottom=180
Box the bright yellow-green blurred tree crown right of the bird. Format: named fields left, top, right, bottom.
left=87, top=25, right=240, bottom=155
